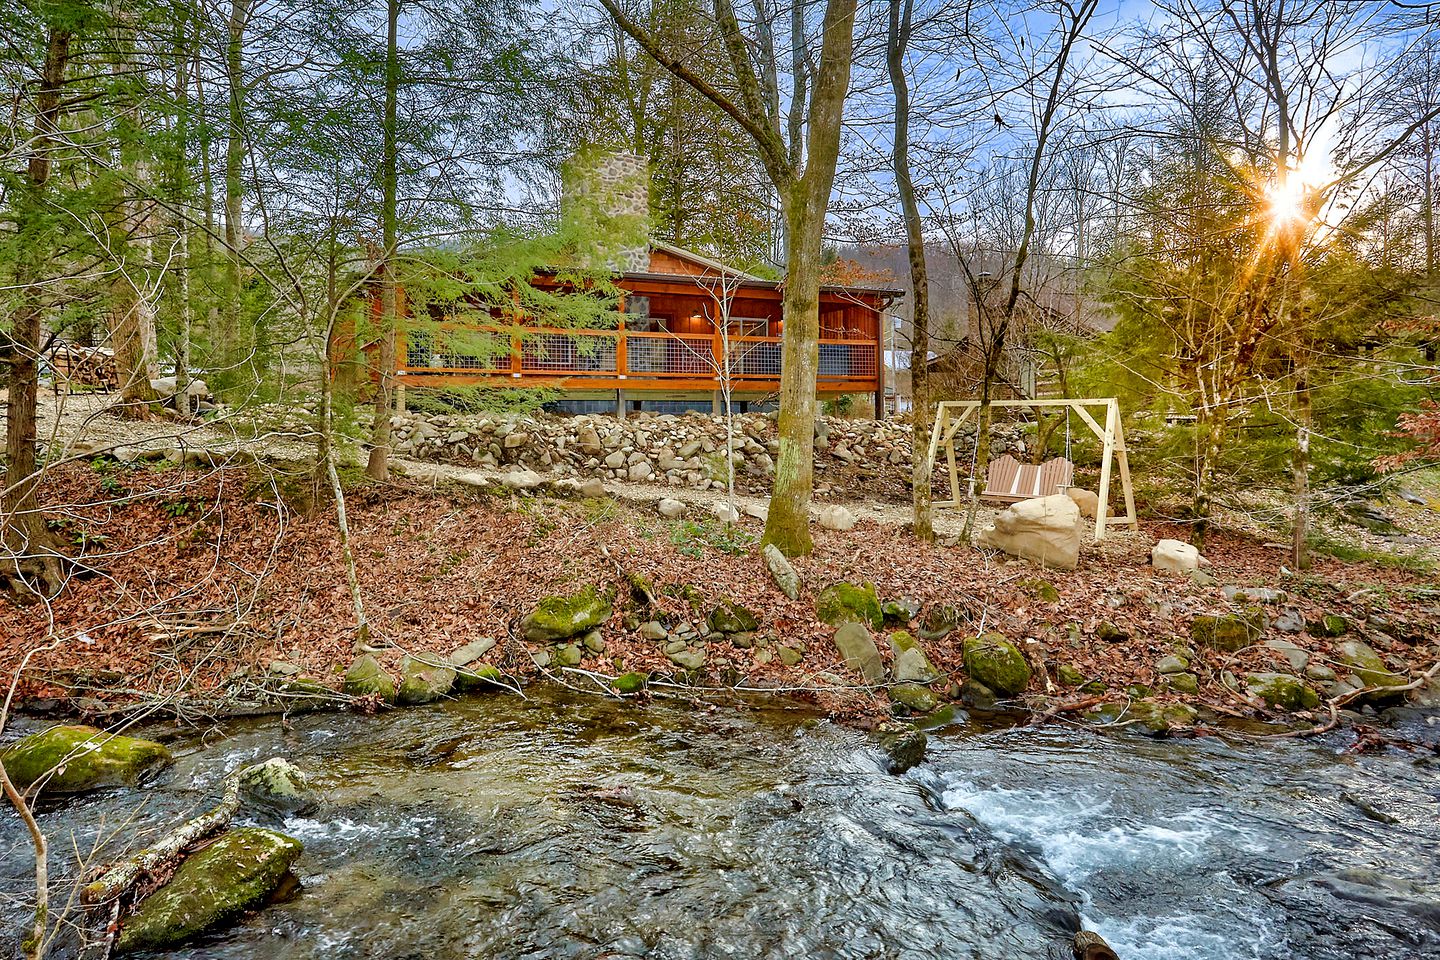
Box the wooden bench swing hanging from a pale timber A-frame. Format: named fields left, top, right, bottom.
left=930, top=397, right=1140, bottom=540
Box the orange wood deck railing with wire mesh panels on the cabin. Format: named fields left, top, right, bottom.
left=402, top=328, right=878, bottom=383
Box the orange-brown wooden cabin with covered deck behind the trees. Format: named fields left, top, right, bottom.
left=396, top=242, right=900, bottom=416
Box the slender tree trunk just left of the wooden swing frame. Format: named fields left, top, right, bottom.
left=886, top=0, right=935, bottom=541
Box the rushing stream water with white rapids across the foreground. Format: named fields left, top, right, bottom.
left=0, top=692, right=1440, bottom=960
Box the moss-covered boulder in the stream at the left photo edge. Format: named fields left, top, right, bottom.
left=0, top=724, right=170, bottom=793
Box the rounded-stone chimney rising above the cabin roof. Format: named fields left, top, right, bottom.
left=560, top=151, right=649, bottom=273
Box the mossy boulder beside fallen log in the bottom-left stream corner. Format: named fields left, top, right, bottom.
left=115, top=828, right=304, bottom=953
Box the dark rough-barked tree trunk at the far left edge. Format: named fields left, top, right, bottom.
left=0, top=27, right=72, bottom=600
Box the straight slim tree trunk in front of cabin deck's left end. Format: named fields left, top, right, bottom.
left=366, top=0, right=400, bottom=481
